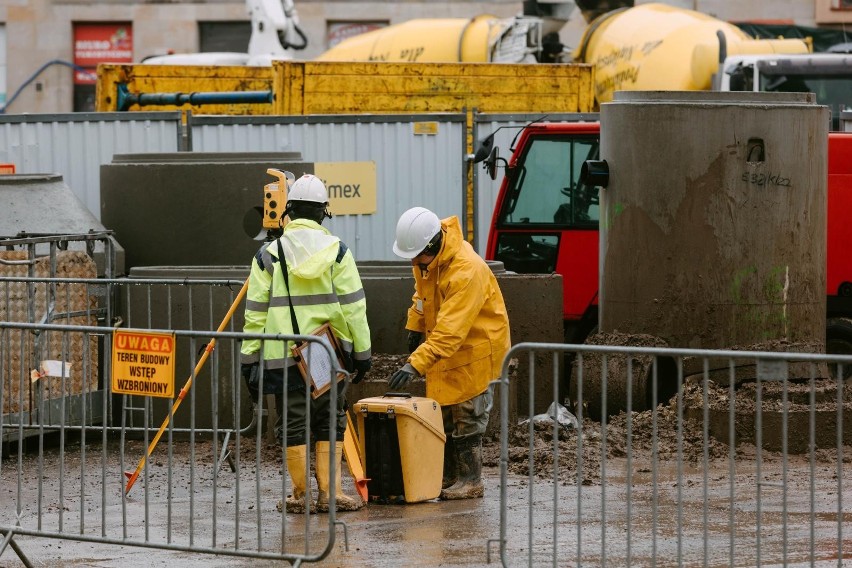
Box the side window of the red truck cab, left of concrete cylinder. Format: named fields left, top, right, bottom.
left=498, top=136, right=600, bottom=228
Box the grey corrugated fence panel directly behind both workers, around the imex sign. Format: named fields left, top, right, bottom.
left=191, top=114, right=465, bottom=261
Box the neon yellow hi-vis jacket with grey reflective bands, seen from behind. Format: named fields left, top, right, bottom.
left=241, top=219, right=371, bottom=369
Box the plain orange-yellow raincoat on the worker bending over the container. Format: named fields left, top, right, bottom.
left=405, top=217, right=511, bottom=405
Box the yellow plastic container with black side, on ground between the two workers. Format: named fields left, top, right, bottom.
left=352, top=393, right=447, bottom=503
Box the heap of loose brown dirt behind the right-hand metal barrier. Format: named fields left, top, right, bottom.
left=362, top=355, right=852, bottom=485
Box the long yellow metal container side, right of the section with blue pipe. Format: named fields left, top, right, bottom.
left=272, top=61, right=594, bottom=115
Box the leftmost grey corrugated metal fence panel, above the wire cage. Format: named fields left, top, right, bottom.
left=0, top=112, right=181, bottom=219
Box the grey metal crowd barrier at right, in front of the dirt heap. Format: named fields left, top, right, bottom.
left=488, top=343, right=852, bottom=566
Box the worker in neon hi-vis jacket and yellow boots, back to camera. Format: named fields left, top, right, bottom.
left=241, top=175, right=371, bottom=513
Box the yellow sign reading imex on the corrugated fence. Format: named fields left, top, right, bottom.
left=314, top=162, right=376, bottom=215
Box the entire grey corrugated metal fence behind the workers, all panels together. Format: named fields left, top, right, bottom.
left=0, top=112, right=597, bottom=260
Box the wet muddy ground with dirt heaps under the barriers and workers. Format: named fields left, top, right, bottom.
left=0, top=355, right=852, bottom=568
